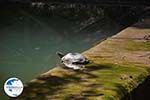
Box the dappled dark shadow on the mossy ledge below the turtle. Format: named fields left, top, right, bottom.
left=11, top=64, right=111, bottom=100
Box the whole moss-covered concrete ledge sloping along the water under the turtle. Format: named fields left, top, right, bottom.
left=11, top=19, right=150, bottom=100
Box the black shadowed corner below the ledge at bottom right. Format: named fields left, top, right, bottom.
left=121, top=76, right=150, bottom=100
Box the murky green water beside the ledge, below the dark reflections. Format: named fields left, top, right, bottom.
left=0, top=6, right=119, bottom=100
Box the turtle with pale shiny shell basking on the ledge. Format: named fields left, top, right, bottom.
left=56, top=52, right=89, bottom=70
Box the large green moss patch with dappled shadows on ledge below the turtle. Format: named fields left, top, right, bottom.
left=16, top=63, right=148, bottom=100
